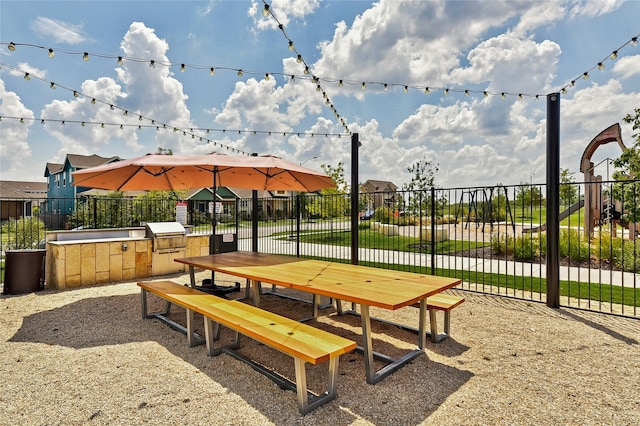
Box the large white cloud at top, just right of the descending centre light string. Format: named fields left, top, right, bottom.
left=313, top=0, right=546, bottom=93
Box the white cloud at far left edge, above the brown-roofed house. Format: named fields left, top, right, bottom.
left=0, top=79, right=34, bottom=180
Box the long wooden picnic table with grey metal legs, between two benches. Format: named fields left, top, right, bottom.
left=175, top=251, right=460, bottom=384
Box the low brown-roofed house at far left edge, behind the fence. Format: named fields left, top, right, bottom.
left=0, top=180, right=47, bottom=220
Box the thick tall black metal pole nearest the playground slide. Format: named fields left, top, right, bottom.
left=547, top=93, right=560, bottom=308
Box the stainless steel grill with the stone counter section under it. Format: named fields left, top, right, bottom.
left=145, top=222, right=187, bottom=276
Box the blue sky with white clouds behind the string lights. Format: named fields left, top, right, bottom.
left=0, top=0, right=640, bottom=187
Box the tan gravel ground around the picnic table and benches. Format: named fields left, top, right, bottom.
left=0, top=275, right=640, bottom=426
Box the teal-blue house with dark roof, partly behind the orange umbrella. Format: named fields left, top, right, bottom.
left=44, top=154, right=121, bottom=215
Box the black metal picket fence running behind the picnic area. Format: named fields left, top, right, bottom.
left=0, top=182, right=640, bottom=317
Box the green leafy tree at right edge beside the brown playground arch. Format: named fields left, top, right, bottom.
left=612, top=108, right=640, bottom=223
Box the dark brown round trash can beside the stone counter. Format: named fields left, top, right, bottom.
left=3, top=250, right=47, bottom=294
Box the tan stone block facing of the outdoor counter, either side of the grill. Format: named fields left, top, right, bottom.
left=45, top=235, right=209, bottom=290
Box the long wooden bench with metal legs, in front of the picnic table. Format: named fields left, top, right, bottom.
left=138, top=281, right=356, bottom=414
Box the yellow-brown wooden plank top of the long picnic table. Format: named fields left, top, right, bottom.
left=176, top=251, right=460, bottom=310
